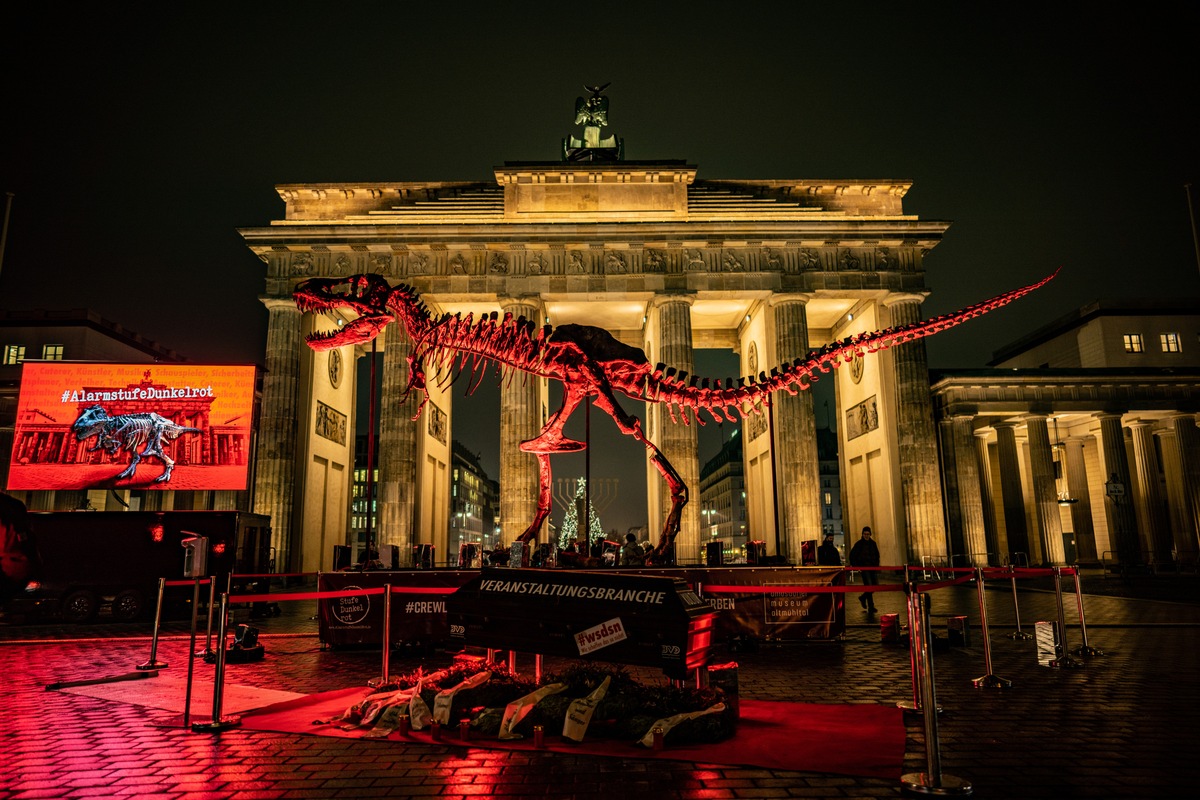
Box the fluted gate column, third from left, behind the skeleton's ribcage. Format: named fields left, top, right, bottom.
left=500, top=296, right=544, bottom=543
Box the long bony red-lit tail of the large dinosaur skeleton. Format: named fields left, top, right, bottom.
left=646, top=270, right=1058, bottom=425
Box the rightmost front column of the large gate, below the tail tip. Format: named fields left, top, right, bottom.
left=884, top=295, right=946, bottom=564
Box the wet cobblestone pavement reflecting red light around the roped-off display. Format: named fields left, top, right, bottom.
left=0, top=566, right=1200, bottom=800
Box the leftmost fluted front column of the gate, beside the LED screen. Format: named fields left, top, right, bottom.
left=254, top=297, right=305, bottom=572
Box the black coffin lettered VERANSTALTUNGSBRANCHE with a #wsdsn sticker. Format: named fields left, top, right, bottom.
left=446, top=569, right=714, bottom=680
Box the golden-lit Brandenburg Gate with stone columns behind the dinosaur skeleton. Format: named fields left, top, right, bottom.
left=240, top=115, right=948, bottom=571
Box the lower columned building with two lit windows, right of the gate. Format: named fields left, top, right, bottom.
left=932, top=302, right=1200, bottom=570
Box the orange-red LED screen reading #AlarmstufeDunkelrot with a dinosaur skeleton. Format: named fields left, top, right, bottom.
left=8, top=361, right=254, bottom=491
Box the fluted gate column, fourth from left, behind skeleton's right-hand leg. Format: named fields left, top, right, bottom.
left=649, top=295, right=700, bottom=564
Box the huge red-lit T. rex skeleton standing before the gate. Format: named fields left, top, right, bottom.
left=295, top=272, right=1057, bottom=563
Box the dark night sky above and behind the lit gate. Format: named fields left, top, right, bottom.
left=0, top=2, right=1200, bottom=537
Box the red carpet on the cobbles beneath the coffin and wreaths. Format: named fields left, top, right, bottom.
left=241, top=687, right=905, bottom=780
